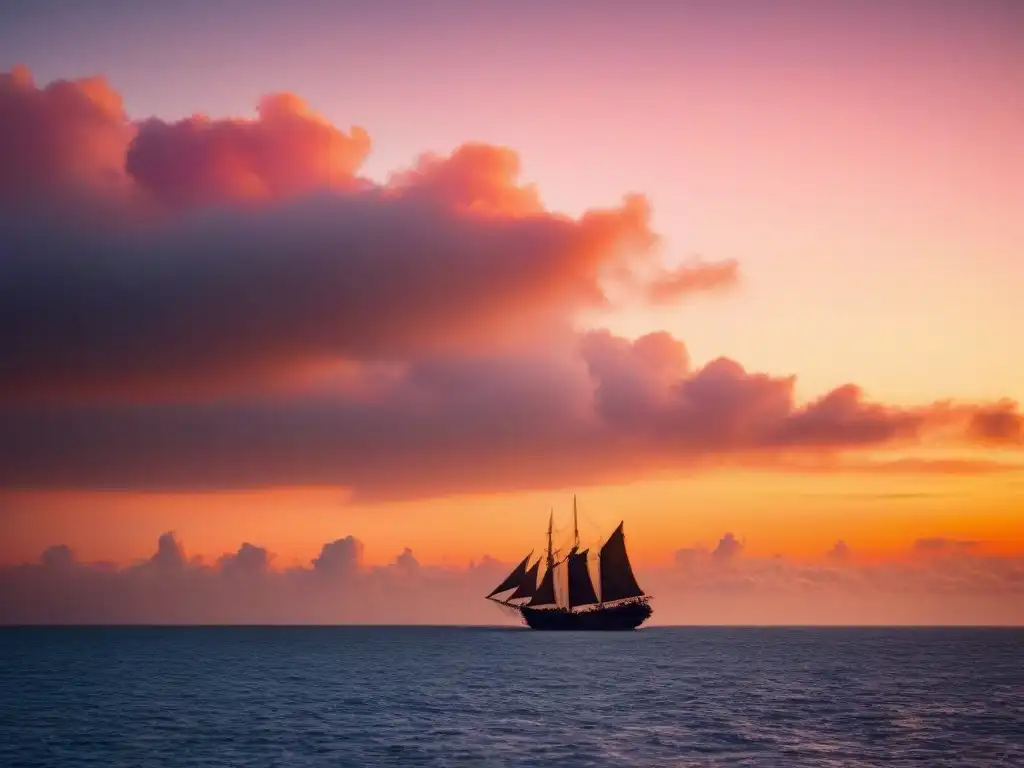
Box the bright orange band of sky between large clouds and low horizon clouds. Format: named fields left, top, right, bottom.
left=0, top=470, right=1024, bottom=567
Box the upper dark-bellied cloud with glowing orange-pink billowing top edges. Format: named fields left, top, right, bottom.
left=0, top=70, right=719, bottom=397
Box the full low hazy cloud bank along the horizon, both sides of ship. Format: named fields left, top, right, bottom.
left=0, top=534, right=1024, bottom=625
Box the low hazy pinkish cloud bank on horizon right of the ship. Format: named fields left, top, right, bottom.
left=655, top=535, right=1024, bottom=625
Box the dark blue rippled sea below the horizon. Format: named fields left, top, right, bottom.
left=0, top=628, right=1024, bottom=768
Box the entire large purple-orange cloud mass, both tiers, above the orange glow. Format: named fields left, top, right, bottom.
left=0, top=70, right=1021, bottom=499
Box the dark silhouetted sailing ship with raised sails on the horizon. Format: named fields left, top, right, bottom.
left=486, top=497, right=653, bottom=631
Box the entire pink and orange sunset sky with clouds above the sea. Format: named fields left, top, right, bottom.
left=0, top=0, right=1024, bottom=624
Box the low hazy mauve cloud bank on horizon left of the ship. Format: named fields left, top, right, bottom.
left=0, top=534, right=511, bottom=625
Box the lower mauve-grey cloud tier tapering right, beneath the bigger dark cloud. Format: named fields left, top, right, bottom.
left=6, top=332, right=1015, bottom=499
